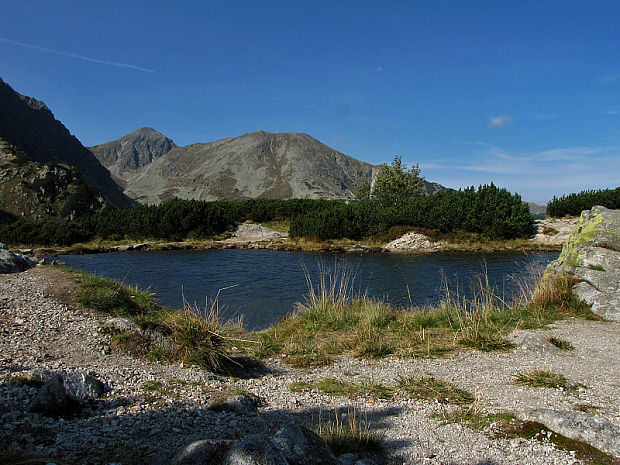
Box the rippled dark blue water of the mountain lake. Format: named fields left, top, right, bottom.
left=58, top=249, right=558, bottom=330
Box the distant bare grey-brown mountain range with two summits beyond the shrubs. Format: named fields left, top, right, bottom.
left=91, top=128, right=442, bottom=204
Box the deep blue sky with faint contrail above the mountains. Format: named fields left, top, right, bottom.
left=0, top=0, right=620, bottom=203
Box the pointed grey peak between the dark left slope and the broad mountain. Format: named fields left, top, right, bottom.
left=88, top=128, right=176, bottom=187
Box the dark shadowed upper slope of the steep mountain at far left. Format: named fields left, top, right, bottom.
left=0, top=79, right=135, bottom=208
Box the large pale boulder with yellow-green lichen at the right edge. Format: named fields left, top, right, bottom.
left=549, top=206, right=620, bottom=321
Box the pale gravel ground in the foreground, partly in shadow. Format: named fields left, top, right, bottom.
left=0, top=267, right=620, bottom=465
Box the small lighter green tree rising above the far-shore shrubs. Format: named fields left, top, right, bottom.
left=371, top=156, right=424, bottom=205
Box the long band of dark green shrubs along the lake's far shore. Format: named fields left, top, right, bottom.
left=0, top=184, right=534, bottom=245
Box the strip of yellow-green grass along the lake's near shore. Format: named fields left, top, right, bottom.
left=54, top=258, right=598, bottom=369
